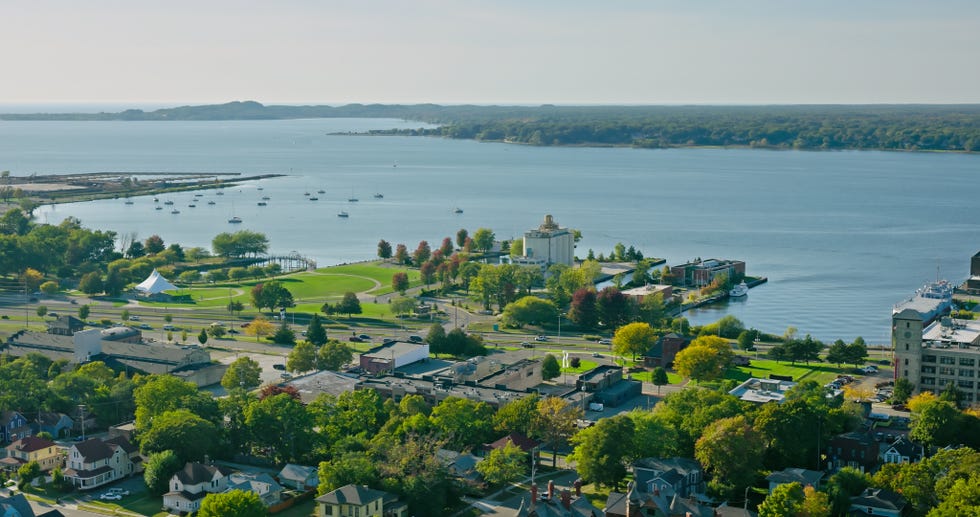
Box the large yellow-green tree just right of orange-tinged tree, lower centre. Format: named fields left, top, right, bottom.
left=569, top=414, right=634, bottom=488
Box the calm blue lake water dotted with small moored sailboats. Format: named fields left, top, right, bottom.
left=0, top=119, right=980, bottom=343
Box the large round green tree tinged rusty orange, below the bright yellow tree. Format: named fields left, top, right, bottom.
left=694, top=415, right=766, bottom=496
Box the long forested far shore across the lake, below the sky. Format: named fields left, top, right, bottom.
left=0, top=101, right=980, bottom=152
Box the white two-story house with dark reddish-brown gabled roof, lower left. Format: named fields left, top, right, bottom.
left=65, top=436, right=142, bottom=490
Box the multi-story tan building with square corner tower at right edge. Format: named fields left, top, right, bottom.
left=892, top=309, right=980, bottom=405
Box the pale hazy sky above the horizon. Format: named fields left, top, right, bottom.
left=0, top=0, right=980, bottom=105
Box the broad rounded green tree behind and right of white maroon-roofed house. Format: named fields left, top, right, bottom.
left=140, top=409, right=218, bottom=463
